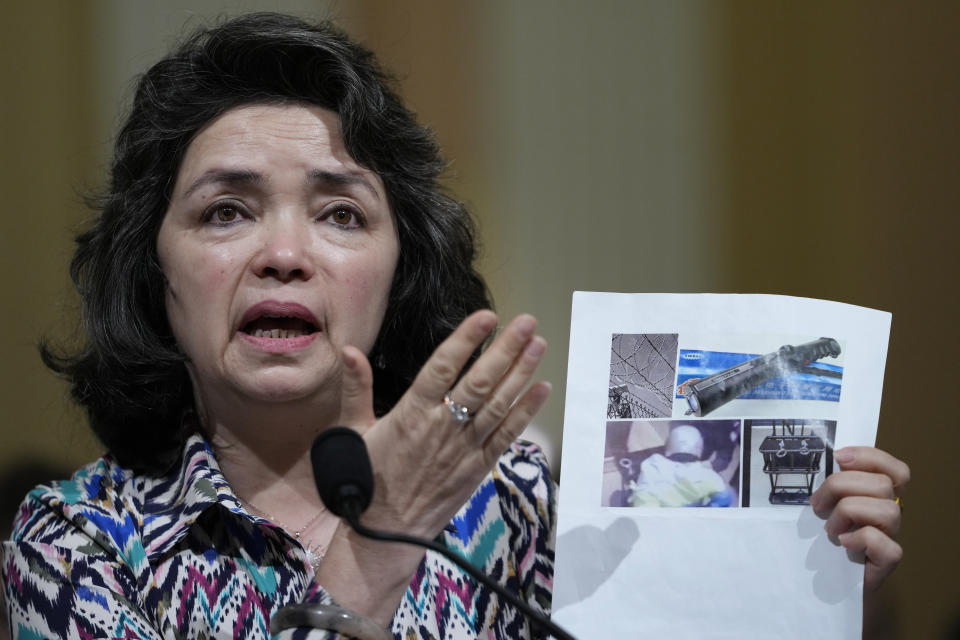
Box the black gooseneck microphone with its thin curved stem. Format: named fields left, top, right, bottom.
left=310, top=427, right=574, bottom=640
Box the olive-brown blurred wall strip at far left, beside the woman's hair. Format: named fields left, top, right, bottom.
left=0, top=2, right=97, bottom=468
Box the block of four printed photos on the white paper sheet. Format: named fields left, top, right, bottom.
left=601, top=333, right=843, bottom=508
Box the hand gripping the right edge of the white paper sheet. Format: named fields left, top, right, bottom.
left=810, top=447, right=910, bottom=591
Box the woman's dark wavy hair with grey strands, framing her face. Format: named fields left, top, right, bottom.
left=41, top=13, right=490, bottom=473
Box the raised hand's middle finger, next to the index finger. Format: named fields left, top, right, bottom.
left=450, top=314, right=537, bottom=412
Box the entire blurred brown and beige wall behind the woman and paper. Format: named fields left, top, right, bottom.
left=0, top=0, right=960, bottom=638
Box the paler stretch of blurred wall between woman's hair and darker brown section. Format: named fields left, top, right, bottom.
left=348, top=0, right=722, bottom=467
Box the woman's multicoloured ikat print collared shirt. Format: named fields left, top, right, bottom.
left=2, top=435, right=555, bottom=640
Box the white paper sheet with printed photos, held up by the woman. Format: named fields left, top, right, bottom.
left=553, top=292, right=890, bottom=640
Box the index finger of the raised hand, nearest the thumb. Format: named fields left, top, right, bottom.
left=410, top=309, right=497, bottom=406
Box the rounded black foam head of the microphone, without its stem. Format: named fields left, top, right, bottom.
left=310, top=427, right=373, bottom=516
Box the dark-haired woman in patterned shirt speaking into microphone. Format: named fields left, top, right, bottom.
left=3, top=14, right=899, bottom=638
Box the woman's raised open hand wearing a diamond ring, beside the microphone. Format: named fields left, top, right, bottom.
left=341, top=311, right=550, bottom=537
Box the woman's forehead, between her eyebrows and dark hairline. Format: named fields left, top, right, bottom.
left=174, top=104, right=383, bottom=194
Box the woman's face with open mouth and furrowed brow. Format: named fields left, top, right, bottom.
left=157, top=105, right=399, bottom=403
